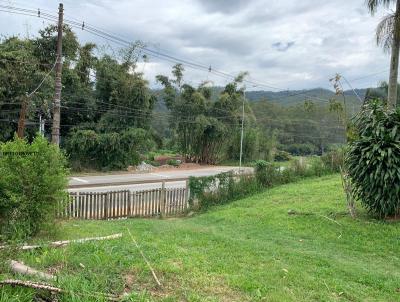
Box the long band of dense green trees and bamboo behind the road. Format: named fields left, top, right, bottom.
left=0, top=26, right=362, bottom=170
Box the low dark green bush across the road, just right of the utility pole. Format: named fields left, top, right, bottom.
left=66, top=128, right=154, bottom=170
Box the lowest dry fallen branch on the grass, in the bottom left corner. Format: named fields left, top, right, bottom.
left=0, top=279, right=121, bottom=301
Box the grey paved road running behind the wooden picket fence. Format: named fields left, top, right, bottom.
left=69, top=167, right=252, bottom=192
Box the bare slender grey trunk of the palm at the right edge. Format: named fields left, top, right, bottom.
left=388, top=0, right=400, bottom=109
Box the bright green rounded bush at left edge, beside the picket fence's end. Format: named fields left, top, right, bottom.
left=0, top=136, right=68, bottom=240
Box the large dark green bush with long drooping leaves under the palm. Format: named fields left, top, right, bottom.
left=345, top=101, right=400, bottom=217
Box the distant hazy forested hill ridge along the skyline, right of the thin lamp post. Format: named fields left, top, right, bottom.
left=246, top=88, right=367, bottom=106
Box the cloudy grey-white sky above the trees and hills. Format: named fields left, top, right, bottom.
left=0, top=0, right=389, bottom=90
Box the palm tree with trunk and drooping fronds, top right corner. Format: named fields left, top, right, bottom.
left=367, top=0, right=400, bottom=108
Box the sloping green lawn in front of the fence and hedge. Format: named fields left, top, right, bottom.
left=0, top=175, right=400, bottom=302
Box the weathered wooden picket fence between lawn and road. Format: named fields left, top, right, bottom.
left=58, top=184, right=189, bottom=219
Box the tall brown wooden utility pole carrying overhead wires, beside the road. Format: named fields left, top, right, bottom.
left=51, top=3, right=64, bottom=146
